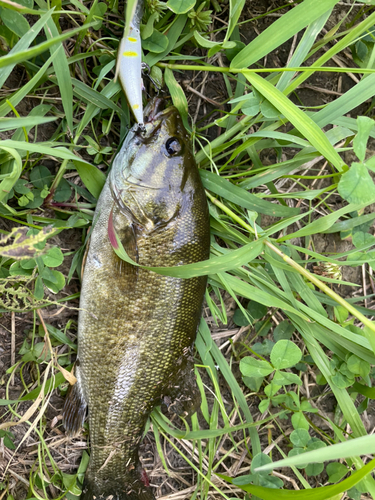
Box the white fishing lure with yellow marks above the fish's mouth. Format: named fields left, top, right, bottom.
left=116, top=0, right=144, bottom=127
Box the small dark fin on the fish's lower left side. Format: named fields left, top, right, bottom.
left=63, top=381, right=87, bottom=437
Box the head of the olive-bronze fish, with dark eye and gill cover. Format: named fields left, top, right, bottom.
left=110, top=99, right=198, bottom=226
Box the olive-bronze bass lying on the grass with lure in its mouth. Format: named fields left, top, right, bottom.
left=63, top=98, right=210, bottom=500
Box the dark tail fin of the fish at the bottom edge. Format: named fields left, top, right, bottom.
left=81, top=474, right=155, bottom=500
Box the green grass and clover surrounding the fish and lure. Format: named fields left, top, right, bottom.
left=0, top=0, right=375, bottom=500
